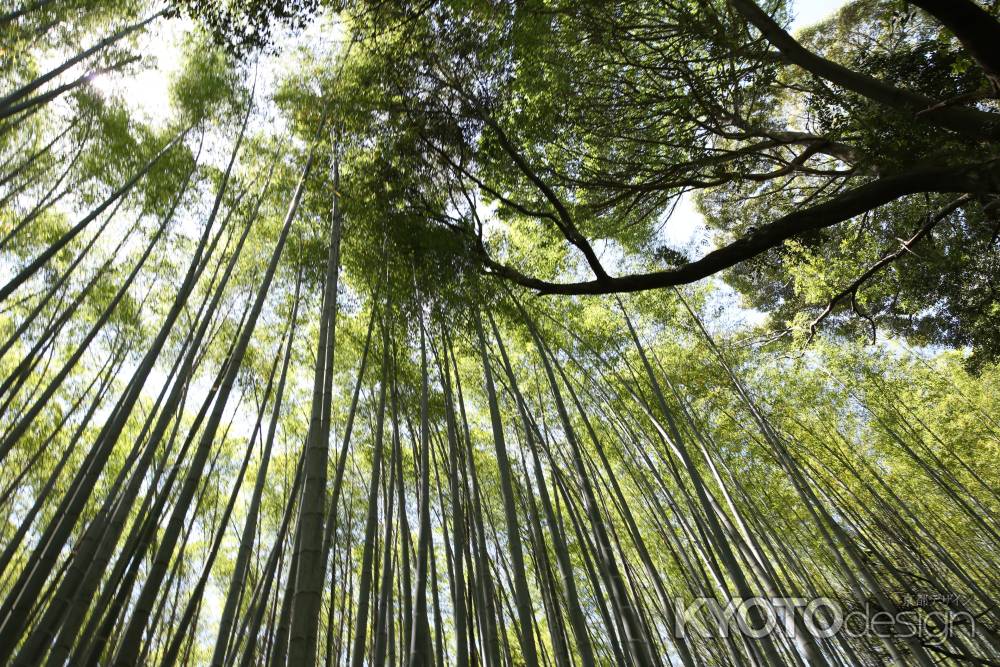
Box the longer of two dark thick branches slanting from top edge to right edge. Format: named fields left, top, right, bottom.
left=729, top=0, right=1000, bottom=139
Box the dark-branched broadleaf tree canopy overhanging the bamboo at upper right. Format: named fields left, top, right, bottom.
left=182, top=0, right=1000, bottom=360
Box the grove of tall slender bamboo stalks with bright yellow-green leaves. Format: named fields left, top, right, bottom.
left=0, top=0, right=1000, bottom=667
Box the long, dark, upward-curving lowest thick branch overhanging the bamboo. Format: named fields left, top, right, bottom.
left=485, top=161, right=1000, bottom=294
